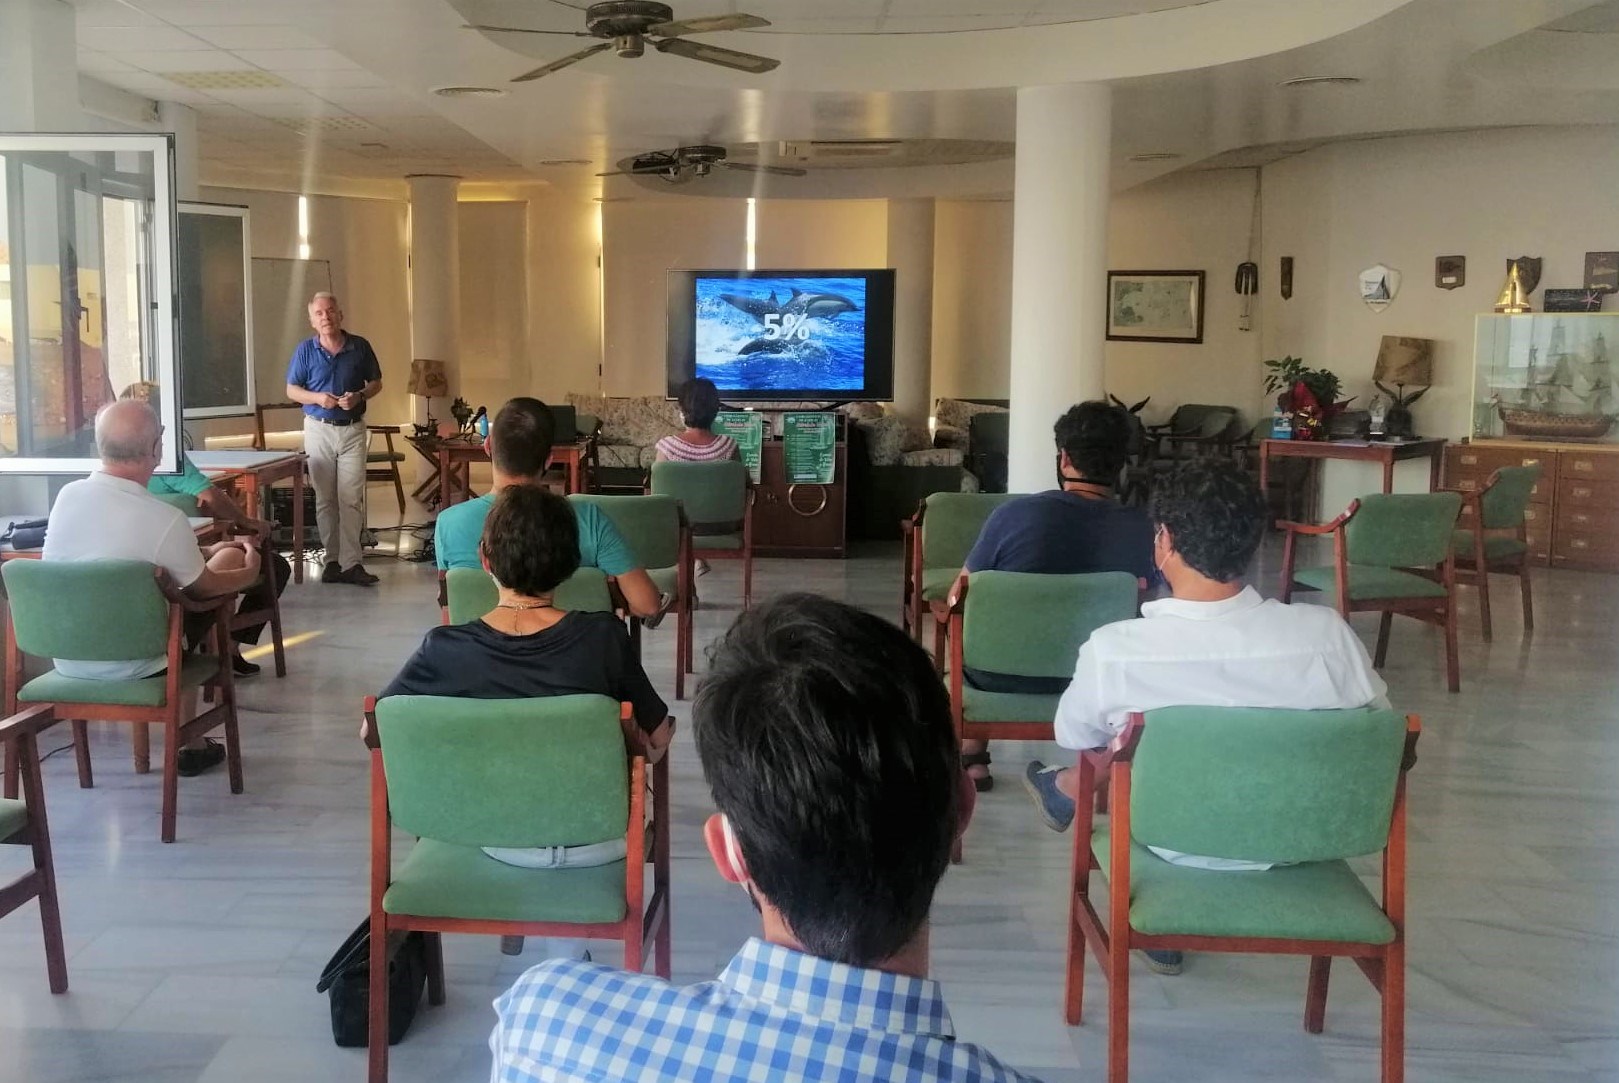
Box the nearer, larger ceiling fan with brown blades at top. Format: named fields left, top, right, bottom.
left=466, top=0, right=782, bottom=83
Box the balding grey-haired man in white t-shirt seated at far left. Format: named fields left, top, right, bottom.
left=44, top=400, right=259, bottom=774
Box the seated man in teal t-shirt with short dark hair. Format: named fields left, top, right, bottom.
left=432, top=397, right=661, bottom=617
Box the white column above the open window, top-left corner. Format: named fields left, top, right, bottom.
left=0, top=0, right=83, bottom=131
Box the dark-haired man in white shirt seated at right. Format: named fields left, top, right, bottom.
left=1023, top=460, right=1387, bottom=973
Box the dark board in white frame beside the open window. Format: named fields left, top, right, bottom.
left=175, top=202, right=253, bottom=419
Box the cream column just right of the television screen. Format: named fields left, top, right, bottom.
left=889, top=199, right=933, bottom=426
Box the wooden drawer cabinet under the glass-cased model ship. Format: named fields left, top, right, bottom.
left=1444, top=440, right=1619, bottom=571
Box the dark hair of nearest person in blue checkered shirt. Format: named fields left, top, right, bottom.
left=691, top=594, right=962, bottom=966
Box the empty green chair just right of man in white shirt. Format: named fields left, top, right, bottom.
left=1279, top=492, right=1462, bottom=691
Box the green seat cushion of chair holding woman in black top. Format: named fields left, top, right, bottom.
left=382, top=839, right=628, bottom=923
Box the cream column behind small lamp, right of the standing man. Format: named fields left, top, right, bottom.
left=404, top=175, right=461, bottom=433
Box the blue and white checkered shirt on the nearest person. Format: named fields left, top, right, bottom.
left=489, top=939, right=1031, bottom=1083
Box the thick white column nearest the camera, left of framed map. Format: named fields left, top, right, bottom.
left=1007, top=83, right=1112, bottom=492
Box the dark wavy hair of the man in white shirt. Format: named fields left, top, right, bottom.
left=1148, top=458, right=1271, bottom=583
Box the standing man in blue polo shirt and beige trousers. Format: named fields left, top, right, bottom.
left=287, top=293, right=382, bottom=586
